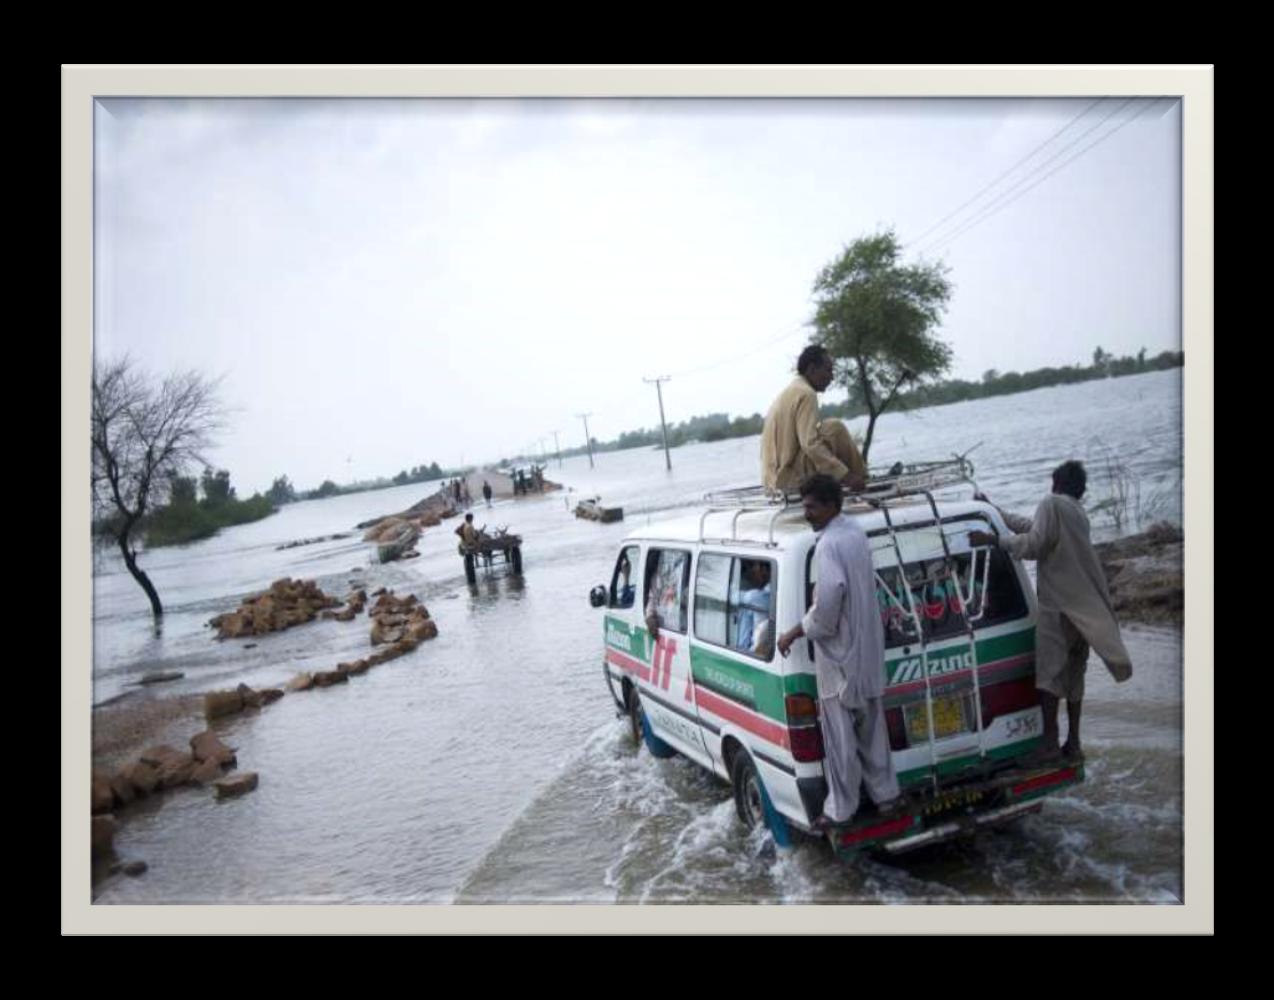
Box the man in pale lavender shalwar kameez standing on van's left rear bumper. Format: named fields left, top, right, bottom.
left=778, top=474, right=898, bottom=831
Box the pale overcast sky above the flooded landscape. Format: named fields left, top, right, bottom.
left=94, top=97, right=1181, bottom=496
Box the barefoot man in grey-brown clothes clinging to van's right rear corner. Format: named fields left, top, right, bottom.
left=968, top=460, right=1133, bottom=764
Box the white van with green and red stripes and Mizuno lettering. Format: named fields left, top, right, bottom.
left=591, top=479, right=1083, bottom=854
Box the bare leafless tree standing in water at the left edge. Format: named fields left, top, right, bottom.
left=92, top=358, right=224, bottom=624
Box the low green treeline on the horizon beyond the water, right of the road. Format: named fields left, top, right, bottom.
left=501, top=348, right=1185, bottom=465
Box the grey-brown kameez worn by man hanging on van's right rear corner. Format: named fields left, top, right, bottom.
left=999, top=493, right=1133, bottom=702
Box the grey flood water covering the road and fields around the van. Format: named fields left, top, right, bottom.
left=85, top=371, right=1182, bottom=903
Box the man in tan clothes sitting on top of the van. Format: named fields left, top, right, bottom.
left=761, top=344, right=868, bottom=493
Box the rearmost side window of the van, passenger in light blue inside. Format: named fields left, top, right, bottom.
left=694, top=553, right=776, bottom=660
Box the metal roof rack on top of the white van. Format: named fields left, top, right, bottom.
left=699, top=453, right=981, bottom=546
